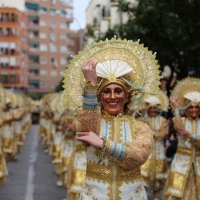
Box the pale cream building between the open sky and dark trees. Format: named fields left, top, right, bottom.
left=86, top=0, right=137, bottom=43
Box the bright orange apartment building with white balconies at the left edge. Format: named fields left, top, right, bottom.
left=0, top=6, right=29, bottom=91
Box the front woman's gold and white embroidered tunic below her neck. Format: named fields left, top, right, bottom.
left=81, top=114, right=152, bottom=200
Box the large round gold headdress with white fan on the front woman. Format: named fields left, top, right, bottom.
left=62, top=38, right=160, bottom=107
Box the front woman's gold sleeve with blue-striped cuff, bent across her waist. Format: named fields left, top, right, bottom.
left=100, top=122, right=153, bottom=169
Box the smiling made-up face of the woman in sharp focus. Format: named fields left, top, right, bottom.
left=100, top=84, right=128, bottom=116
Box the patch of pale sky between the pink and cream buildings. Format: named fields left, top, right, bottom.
left=70, top=0, right=90, bottom=30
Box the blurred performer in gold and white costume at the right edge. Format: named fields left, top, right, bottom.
left=163, top=78, right=200, bottom=200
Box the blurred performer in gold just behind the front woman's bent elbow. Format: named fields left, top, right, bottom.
left=141, top=90, right=169, bottom=200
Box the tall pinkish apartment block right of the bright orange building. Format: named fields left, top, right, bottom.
left=25, top=0, right=74, bottom=93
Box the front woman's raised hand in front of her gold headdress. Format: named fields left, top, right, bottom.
left=82, top=60, right=97, bottom=85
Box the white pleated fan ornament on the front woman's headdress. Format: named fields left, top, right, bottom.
left=96, top=60, right=133, bottom=79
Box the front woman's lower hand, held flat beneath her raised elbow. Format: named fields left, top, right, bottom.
left=76, top=131, right=103, bottom=148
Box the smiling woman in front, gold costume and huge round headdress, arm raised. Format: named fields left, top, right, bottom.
left=64, top=38, right=160, bottom=200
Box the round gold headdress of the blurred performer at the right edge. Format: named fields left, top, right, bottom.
left=171, top=78, right=200, bottom=109
